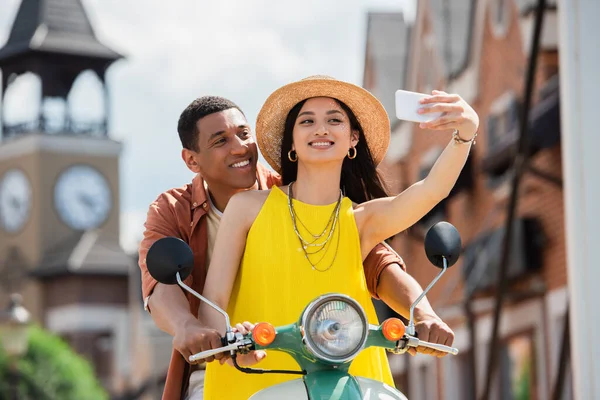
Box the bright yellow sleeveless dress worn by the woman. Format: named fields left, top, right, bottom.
left=204, top=186, right=394, bottom=400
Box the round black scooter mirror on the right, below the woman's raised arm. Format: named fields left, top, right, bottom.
left=425, top=221, right=462, bottom=268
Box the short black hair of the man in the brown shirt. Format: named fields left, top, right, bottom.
left=177, top=96, right=244, bottom=151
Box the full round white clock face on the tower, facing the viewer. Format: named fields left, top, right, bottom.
left=54, top=165, right=112, bottom=230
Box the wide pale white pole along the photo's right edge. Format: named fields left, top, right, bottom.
left=558, top=0, right=600, bottom=400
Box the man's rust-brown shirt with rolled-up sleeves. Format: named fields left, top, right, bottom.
left=139, top=164, right=405, bottom=400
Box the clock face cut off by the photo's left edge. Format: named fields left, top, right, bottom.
left=0, top=169, right=31, bottom=233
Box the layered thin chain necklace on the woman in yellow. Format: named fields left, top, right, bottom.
left=288, top=182, right=343, bottom=272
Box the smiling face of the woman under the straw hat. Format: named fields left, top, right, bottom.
left=292, top=97, right=358, bottom=167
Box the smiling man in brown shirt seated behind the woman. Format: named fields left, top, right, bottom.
left=139, top=96, right=454, bottom=400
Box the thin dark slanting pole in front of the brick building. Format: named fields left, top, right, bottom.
left=481, top=0, right=546, bottom=400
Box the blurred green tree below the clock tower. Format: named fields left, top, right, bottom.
left=0, top=326, right=108, bottom=400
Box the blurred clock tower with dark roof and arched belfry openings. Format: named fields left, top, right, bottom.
left=0, top=0, right=131, bottom=392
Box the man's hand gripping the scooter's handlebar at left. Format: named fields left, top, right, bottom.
left=173, top=318, right=229, bottom=364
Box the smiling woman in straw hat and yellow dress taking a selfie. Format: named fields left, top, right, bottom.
left=199, top=76, right=479, bottom=399
